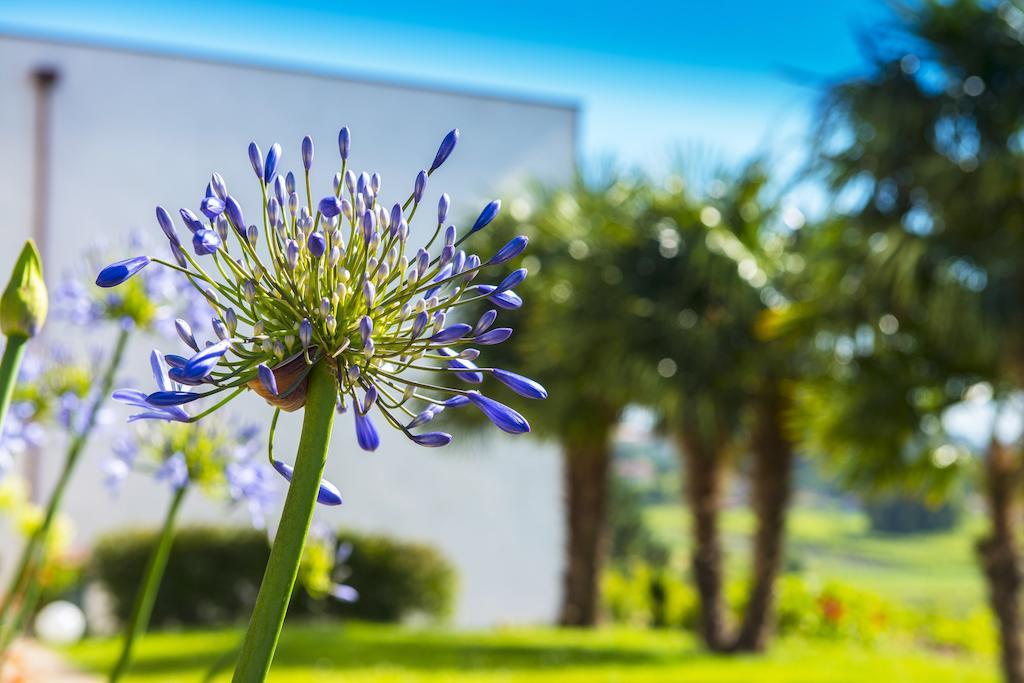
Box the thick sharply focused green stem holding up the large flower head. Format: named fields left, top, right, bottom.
left=231, top=358, right=338, bottom=683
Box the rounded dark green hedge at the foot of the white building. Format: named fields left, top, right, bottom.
left=89, top=526, right=456, bottom=628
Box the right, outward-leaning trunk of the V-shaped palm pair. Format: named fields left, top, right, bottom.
left=733, top=386, right=793, bottom=652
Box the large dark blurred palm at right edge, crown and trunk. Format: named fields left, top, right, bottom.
left=791, top=0, right=1024, bottom=683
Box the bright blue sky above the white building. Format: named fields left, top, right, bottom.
left=0, top=0, right=887, bottom=176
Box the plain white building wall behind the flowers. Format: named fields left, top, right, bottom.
left=0, top=36, right=577, bottom=625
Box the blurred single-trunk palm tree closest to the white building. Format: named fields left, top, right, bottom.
left=477, top=173, right=648, bottom=626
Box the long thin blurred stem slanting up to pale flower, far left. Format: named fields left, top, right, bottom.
left=0, top=329, right=130, bottom=652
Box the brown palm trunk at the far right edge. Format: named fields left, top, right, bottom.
left=977, top=437, right=1024, bottom=683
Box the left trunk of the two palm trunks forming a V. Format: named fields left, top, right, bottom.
left=678, top=425, right=726, bottom=651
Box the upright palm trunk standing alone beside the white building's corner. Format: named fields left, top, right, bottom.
left=559, top=435, right=611, bottom=627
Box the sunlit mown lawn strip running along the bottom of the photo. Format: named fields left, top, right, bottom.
left=66, top=624, right=996, bottom=683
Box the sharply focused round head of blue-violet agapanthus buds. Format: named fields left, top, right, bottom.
left=96, top=128, right=547, bottom=497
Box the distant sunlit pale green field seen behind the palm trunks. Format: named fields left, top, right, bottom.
left=646, top=505, right=985, bottom=613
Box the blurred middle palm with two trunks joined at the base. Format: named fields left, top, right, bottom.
left=628, top=162, right=803, bottom=651
